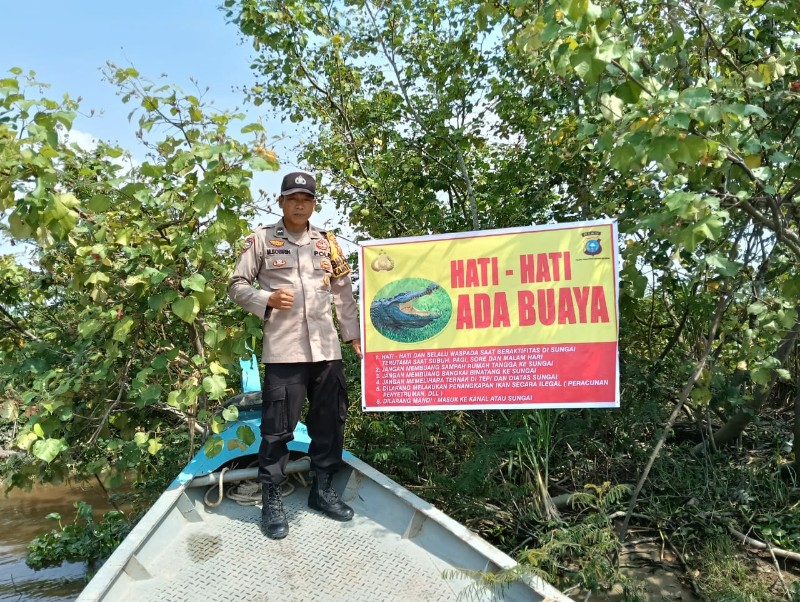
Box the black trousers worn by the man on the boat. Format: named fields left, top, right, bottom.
left=258, top=360, right=348, bottom=485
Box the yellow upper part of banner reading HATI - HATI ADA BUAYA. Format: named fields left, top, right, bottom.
left=360, top=220, right=618, bottom=352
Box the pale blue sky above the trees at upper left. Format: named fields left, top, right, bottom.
left=0, top=0, right=352, bottom=253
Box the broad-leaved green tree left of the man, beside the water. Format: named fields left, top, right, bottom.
left=0, top=65, right=277, bottom=486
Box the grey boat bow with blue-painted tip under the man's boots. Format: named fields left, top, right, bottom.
left=78, top=393, right=571, bottom=602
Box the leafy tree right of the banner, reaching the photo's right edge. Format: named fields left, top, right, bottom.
left=500, top=0, right=800, bottom=454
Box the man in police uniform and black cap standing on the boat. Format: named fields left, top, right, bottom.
left=228, top=172, right=361, bottom=539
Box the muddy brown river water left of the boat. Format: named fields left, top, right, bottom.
left=0, top=481, right=119, bottom=602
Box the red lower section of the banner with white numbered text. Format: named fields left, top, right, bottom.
left=363, top=341, right=619, bottom=411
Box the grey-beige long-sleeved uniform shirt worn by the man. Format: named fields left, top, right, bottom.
left=228, top=220, right=360, bottom=363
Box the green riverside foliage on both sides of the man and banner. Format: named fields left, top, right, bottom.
left=0, top=0, right=800, bottom=600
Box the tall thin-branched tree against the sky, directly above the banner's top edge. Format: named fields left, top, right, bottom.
left=225, top=0, right=564, bottom=237
